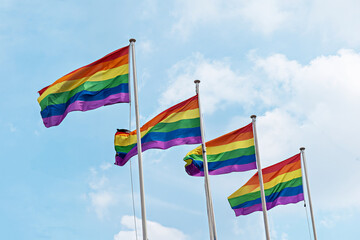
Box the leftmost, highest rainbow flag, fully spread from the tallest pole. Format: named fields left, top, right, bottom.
left=38, top=46, right=129, bottom=127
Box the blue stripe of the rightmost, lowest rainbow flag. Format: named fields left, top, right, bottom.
left=232, top=185, right=303, bottom=209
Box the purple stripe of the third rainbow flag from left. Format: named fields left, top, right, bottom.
left=185, top=162, right=256, bottom=177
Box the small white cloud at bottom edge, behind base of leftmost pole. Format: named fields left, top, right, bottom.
left=114, top=216, right=188, bottom=240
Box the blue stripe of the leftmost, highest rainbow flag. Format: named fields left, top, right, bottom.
left=41, top=83, right=129, bottom=118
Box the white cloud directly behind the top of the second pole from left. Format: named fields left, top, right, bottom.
left=159, top=54, right=252, bottom=113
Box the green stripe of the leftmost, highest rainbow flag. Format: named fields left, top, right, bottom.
left=40, top=74, right=129, bottom=111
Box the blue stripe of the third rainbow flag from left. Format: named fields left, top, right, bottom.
left=190, top=154, right=256, bottom=172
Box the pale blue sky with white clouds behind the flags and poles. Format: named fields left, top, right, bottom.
left=0, top=0, right=360, bottom=240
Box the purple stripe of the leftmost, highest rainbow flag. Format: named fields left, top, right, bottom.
left=43, top=93, right=129, bottom=127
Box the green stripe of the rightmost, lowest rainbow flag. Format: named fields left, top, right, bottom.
left=229, top=177, right=302, bottom=206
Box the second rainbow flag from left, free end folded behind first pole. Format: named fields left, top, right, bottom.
left=114, top=95, right=201, bottom=166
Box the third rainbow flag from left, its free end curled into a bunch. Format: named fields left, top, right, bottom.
left=184, top=123, right=256, bottom=176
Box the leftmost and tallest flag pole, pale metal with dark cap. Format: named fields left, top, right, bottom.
left=129, top=38, right=147, bottom=240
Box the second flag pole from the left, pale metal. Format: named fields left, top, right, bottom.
left=194, top=80, right=217, bottom=240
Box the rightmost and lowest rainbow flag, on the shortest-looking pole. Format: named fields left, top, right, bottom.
left=228, top=153, right=304, bottom=216
